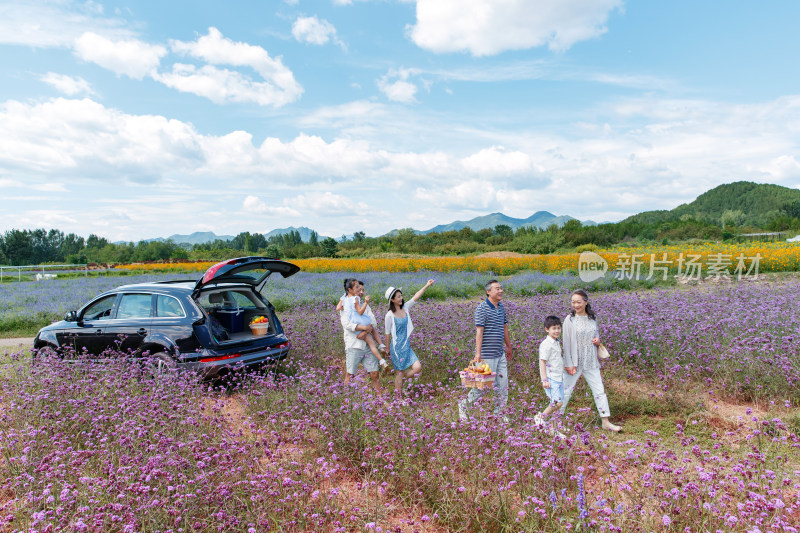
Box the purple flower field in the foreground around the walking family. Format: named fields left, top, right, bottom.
left=0, top=280, right=800, bottom=532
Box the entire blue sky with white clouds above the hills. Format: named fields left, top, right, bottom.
left=0, top=0, right=800, bottom=241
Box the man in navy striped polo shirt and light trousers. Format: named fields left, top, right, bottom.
left=458, top=279, right=511, bottom=423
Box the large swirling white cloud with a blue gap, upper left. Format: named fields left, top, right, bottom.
left=162, top=28, right=303, bottom=107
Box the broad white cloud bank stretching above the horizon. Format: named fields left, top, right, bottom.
left=0, top=96, right=800, bottom=235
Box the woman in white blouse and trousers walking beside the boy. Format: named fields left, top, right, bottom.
left=561, top=290, right=620, bottom=432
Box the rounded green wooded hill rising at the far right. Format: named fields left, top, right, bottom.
left=622, top=181, right=800, bottom=227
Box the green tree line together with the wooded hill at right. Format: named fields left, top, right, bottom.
left=6, top=181, right=800, bottom=265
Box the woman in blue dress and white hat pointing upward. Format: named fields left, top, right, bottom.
left=385, top=279, right=433, bottom=398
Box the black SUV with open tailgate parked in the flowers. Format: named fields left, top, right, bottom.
left=33, top=257, right=300, bottom=378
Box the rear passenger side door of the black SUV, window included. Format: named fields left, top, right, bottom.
left=103, top=292, right=154, bottom=354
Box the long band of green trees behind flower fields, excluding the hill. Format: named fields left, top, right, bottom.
left=0, top=212, right=800, bottom=265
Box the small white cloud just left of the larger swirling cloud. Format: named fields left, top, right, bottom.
left=75, top=32, right=167, bottom=80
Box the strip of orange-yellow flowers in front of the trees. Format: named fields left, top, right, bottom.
left=116, top=242, right=800, bottom=275
